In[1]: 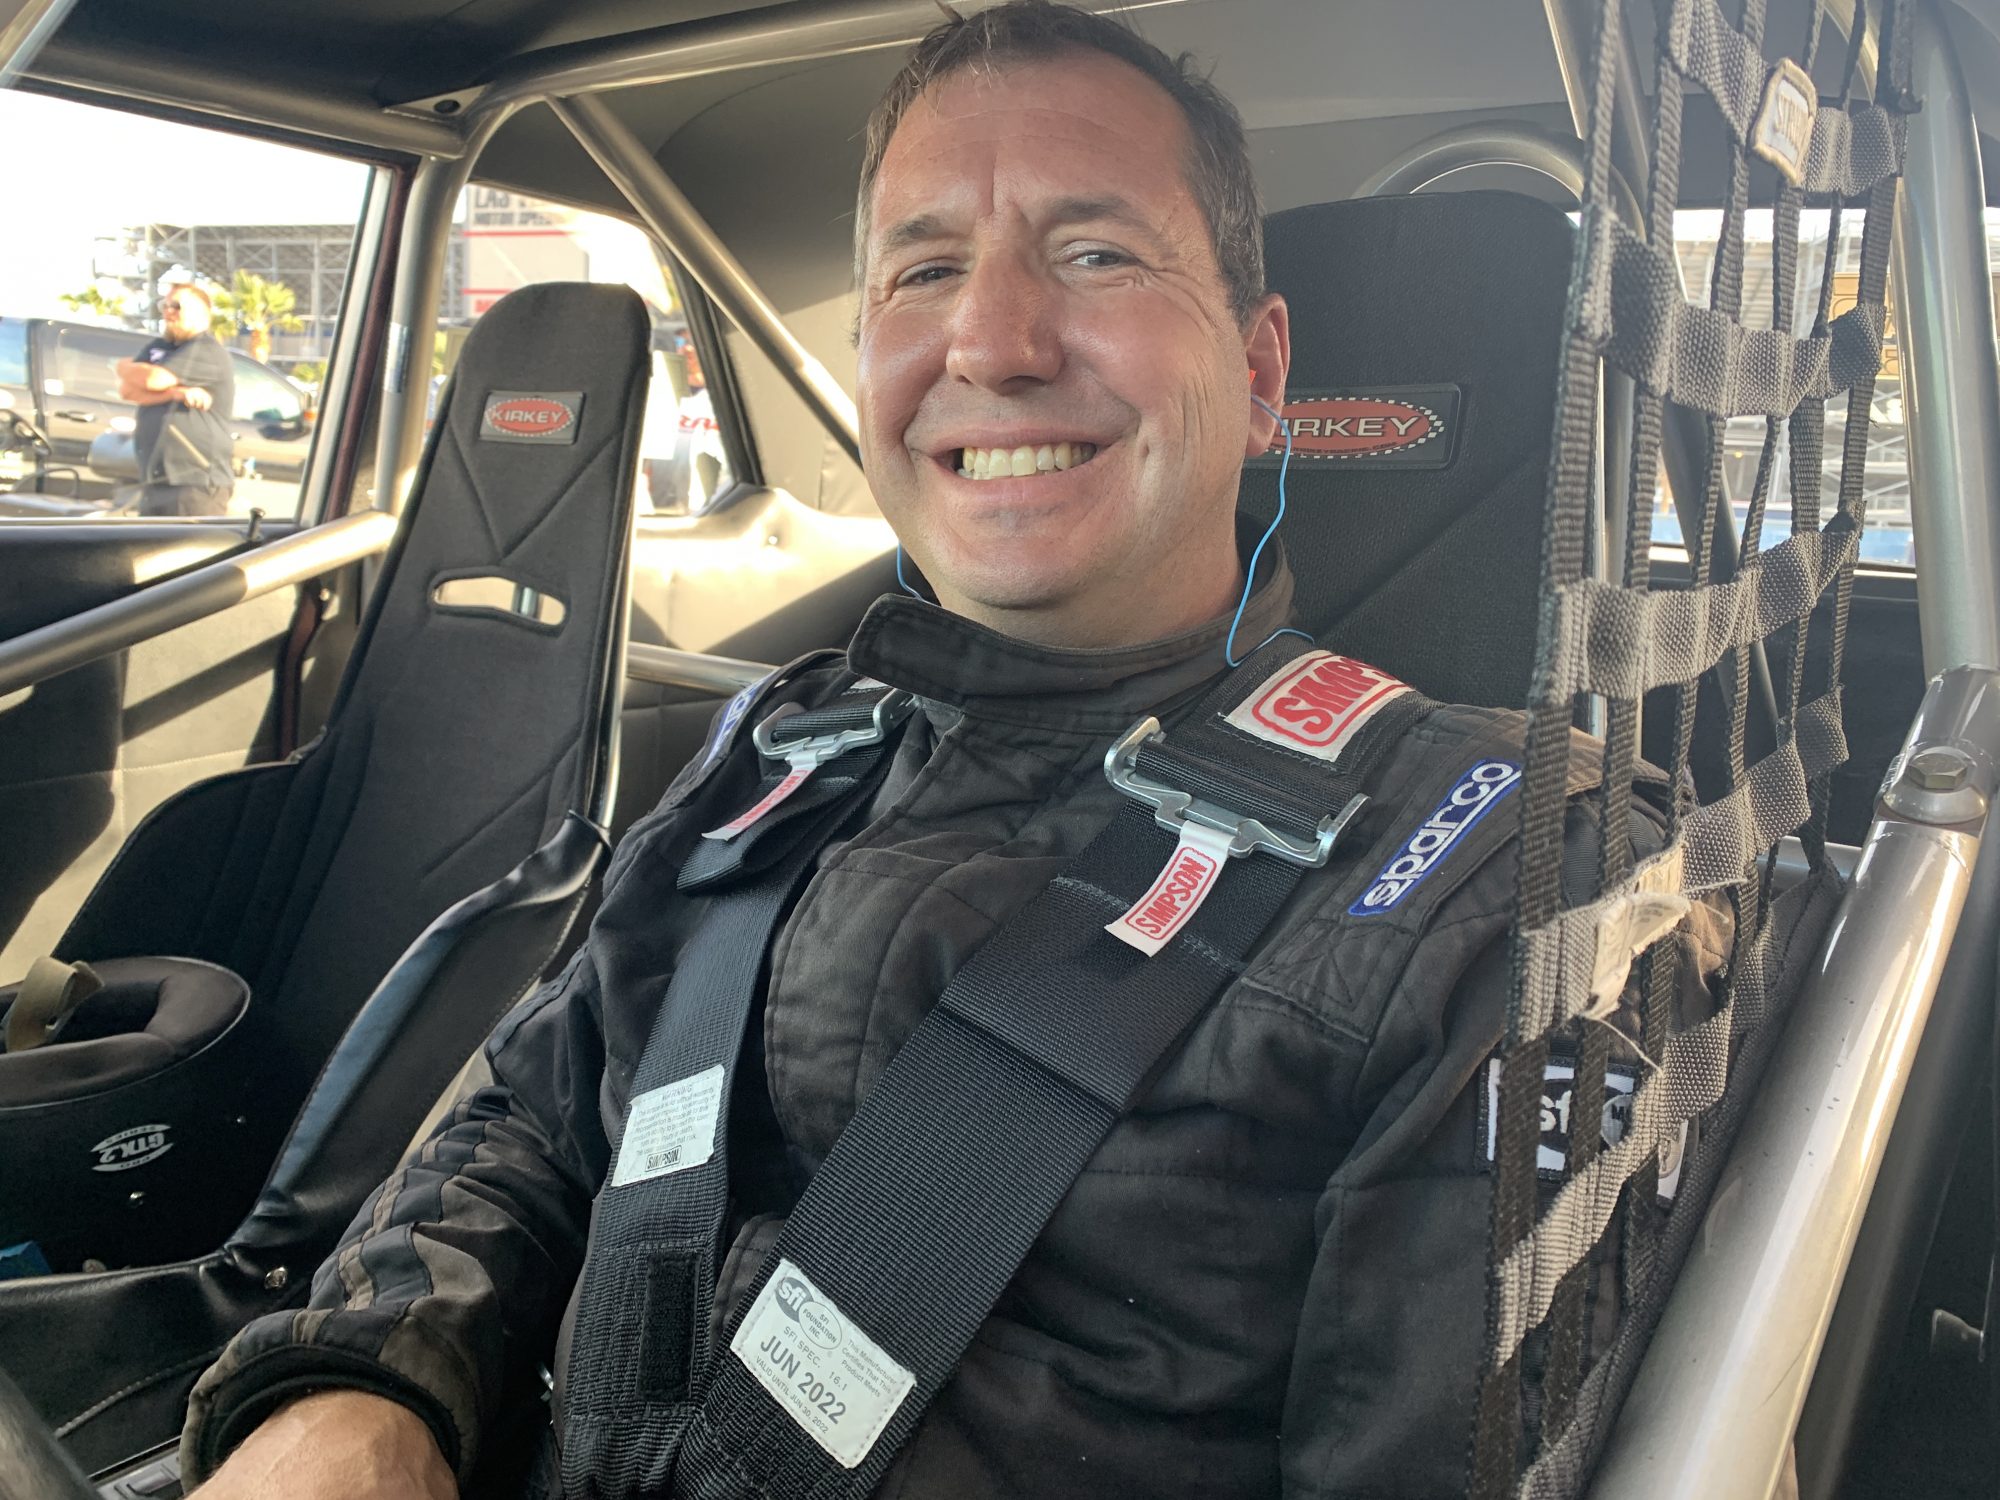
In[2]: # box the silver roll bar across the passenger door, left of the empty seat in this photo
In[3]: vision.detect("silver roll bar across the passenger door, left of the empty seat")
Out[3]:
[0,510,396,694]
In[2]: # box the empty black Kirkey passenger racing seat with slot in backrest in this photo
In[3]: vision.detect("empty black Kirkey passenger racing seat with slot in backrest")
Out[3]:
[0,284,650,1464]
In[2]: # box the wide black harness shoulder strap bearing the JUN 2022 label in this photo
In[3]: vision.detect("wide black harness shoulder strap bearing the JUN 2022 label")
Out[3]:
[664,640,1430,1500]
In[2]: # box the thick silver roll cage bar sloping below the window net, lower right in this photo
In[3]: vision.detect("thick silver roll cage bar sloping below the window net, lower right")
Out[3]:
[1590,668,2000,1500]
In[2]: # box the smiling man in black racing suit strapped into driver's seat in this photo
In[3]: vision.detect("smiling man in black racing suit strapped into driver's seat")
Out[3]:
[182,0,1714,1500]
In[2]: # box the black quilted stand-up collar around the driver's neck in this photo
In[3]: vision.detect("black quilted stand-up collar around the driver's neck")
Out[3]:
[848,522,1292,736]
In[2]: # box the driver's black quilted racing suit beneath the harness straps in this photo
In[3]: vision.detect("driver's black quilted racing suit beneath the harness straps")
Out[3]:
[184,564,1724,1500]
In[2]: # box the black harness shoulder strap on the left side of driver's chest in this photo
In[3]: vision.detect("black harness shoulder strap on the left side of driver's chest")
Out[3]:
[562,684,914,1494]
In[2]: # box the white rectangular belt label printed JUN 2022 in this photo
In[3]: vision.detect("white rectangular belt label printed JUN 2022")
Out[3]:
[730,1260,916,1468]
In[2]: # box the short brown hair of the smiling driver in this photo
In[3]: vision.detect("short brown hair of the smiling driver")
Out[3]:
[854,0,1264,322]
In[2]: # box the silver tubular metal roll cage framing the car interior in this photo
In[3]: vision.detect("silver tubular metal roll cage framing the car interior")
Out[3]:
[0,0,2000,1500]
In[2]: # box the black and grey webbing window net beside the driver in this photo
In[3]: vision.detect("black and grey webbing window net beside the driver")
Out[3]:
[1472,0,1908,1500]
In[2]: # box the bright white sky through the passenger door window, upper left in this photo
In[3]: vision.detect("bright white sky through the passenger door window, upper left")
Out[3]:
[0,92,368,318]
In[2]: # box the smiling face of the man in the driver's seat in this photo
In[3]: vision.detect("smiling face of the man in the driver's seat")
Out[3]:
[858,52,1290,646]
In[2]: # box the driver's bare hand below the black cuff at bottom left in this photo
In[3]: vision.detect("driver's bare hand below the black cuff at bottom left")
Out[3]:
[196,1390,458,1500]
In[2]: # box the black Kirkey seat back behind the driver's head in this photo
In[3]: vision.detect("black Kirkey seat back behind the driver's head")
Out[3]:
[1242,192,1576,708]
